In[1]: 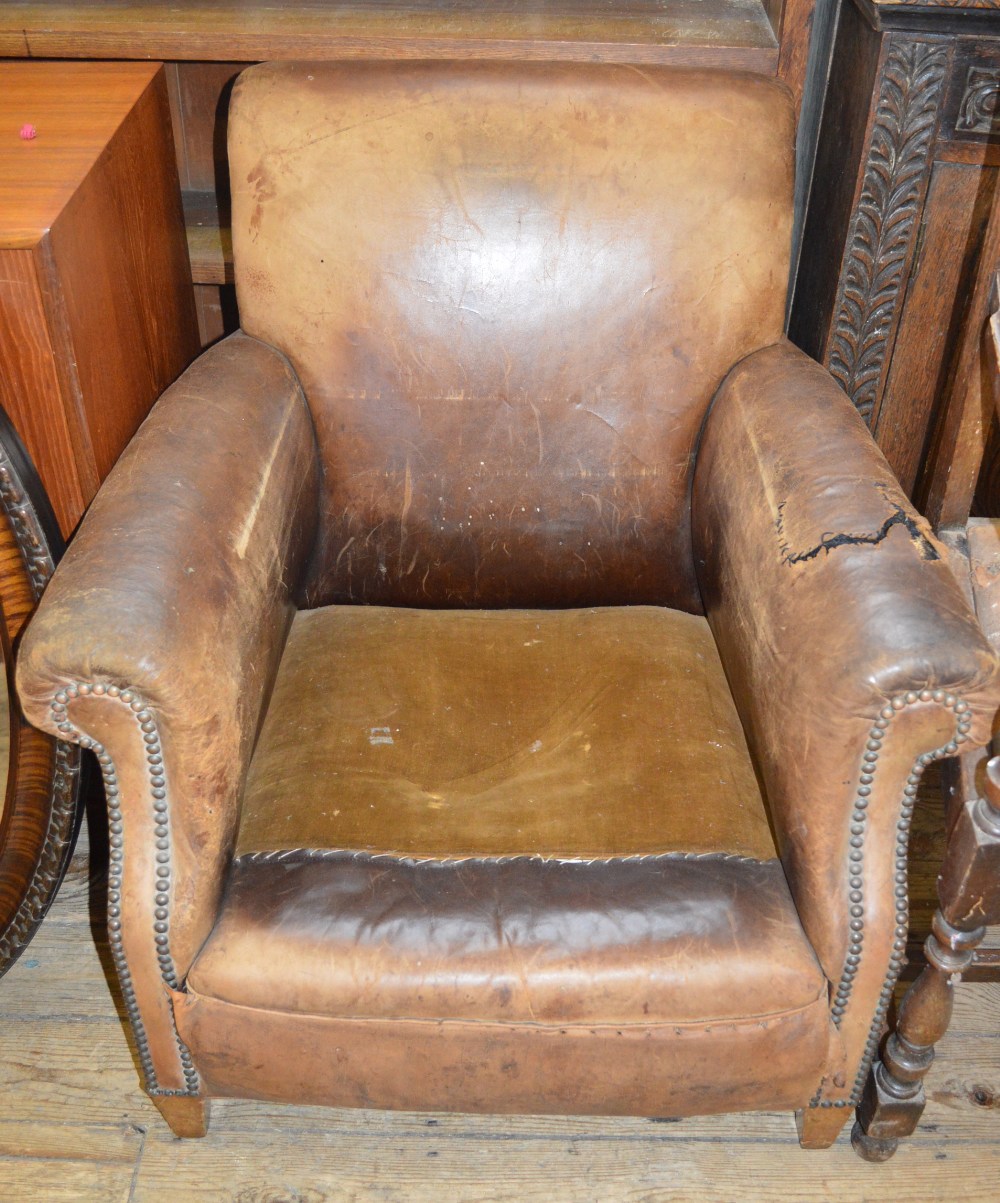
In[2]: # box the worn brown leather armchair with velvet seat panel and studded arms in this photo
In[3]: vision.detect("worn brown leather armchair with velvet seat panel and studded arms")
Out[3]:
[19,63,1000,1146]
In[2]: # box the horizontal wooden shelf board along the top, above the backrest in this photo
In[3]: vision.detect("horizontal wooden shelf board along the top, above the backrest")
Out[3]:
[0,0,777,75]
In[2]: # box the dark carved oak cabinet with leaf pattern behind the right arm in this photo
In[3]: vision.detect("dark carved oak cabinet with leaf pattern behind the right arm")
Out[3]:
[789,0,1000,502]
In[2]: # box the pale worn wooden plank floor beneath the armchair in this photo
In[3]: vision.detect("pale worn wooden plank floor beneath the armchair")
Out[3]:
[0,789,1000,1203]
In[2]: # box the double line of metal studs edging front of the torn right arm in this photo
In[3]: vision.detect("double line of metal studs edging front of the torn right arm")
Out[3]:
[811,689,972,1107]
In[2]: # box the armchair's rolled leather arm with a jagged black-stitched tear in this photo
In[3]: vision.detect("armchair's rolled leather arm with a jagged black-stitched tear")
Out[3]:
[692,342,1000,1094]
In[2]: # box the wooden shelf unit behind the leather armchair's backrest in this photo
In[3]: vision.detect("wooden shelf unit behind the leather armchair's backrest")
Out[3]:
[0,0,816,343]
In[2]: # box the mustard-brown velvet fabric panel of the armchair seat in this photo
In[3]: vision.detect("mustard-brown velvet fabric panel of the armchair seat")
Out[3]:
[237,606,776,859]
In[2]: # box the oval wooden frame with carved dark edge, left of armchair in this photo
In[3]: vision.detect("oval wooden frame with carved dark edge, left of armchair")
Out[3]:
[0,409,81,976]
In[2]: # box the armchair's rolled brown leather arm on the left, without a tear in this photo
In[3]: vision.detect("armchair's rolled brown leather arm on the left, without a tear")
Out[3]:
[17,334,318,983]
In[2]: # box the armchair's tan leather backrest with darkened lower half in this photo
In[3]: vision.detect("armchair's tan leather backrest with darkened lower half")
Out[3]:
[230,63,793,610]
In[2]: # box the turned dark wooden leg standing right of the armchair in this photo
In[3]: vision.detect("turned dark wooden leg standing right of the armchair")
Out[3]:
[851,757,1000,1161]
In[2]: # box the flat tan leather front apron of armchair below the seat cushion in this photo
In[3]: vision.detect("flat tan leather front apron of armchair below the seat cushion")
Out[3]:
[174,994,827,1116]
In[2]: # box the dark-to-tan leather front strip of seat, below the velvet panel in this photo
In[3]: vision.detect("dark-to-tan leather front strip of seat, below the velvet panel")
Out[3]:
[188,854,827,1026]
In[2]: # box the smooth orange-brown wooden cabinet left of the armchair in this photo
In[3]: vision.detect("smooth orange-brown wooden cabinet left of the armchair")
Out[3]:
[0,63,199,535]
